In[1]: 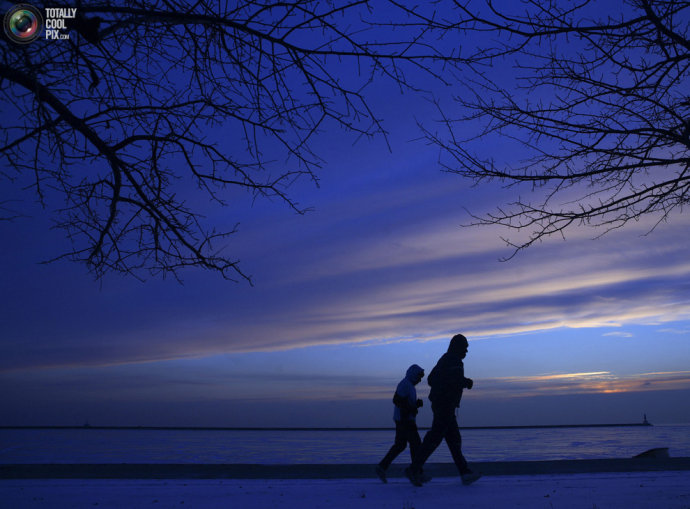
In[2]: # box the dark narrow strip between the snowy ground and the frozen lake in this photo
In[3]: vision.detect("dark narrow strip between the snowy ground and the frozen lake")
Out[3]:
[0,458,690,479]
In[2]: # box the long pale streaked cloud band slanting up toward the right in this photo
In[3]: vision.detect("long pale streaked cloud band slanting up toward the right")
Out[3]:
[2,211,690,370]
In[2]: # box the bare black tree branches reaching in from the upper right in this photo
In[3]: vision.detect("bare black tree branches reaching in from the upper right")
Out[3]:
[411,0,690,255]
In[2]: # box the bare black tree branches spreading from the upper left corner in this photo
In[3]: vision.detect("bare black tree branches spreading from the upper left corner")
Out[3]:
[0,0,462,279]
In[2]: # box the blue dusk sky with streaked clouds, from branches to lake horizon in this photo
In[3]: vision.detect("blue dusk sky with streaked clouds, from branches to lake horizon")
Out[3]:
[0,0,690,426]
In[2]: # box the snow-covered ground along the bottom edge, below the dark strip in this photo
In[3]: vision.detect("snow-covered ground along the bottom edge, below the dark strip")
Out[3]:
[0,471,690,509]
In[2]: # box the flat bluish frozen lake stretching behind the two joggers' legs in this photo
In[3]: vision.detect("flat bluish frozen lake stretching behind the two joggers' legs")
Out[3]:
[0,425,690,464]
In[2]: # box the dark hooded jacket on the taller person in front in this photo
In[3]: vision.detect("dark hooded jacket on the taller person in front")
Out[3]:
[427,335,471,408]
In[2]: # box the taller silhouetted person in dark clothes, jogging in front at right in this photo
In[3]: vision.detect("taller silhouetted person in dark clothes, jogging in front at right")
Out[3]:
[405,334,481,486]
